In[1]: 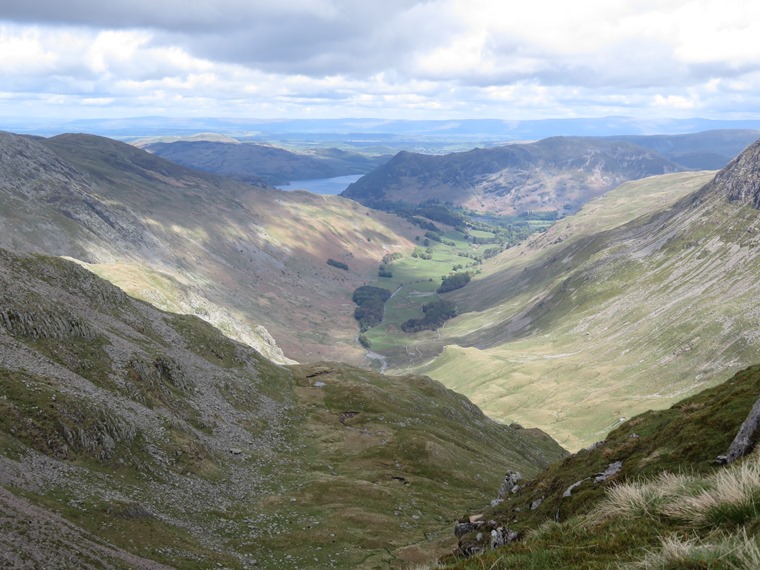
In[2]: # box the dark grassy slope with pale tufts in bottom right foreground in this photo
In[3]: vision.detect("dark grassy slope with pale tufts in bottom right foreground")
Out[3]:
[446,366,760,570]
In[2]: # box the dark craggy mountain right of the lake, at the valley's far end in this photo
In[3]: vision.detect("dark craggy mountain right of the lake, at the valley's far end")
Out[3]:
[342,137,684,215]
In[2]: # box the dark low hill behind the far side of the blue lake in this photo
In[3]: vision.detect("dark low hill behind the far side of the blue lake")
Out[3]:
[139,141,388,184]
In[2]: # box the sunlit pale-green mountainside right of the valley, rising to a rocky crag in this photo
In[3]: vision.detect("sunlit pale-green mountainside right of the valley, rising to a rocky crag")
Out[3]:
[407,138,760,449]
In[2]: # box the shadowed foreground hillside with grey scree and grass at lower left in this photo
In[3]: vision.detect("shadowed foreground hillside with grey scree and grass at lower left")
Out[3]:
[0,250,564,568]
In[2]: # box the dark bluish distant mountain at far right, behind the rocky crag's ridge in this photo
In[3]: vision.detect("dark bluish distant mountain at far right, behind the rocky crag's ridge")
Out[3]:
[609,129,760,170]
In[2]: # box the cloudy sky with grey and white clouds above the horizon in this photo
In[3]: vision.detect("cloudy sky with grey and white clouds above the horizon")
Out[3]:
[0,0,760,120]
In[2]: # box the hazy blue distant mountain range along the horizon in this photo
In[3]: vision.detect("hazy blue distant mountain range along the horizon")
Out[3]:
[5,113,760,140]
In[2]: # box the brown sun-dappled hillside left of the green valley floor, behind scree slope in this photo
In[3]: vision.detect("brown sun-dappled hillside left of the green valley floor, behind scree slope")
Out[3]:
[0,133,414,363]
